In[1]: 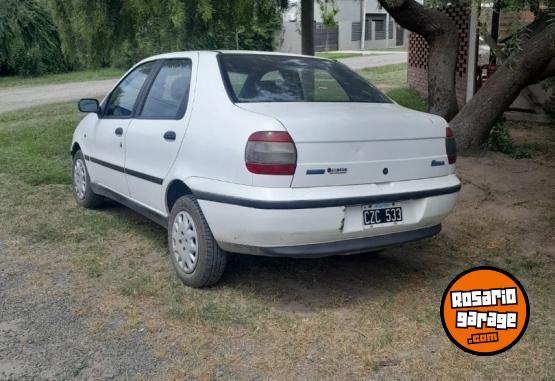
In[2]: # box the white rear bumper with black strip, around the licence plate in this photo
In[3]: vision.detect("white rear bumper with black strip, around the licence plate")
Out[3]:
[188,175,460,257]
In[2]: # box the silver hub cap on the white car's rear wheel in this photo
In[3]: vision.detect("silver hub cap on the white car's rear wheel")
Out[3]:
[172,212,202,273]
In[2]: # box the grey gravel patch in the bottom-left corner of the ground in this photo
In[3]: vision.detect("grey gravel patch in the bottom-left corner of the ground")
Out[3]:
[0,259,158,381]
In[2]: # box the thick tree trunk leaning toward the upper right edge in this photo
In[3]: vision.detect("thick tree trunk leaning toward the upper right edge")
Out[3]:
[450,22,555,151]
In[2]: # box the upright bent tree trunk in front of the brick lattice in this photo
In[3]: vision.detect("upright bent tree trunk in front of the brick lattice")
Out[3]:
[378,0,459,120]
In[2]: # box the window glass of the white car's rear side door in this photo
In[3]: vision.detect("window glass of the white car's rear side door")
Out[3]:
[141,59,191,119]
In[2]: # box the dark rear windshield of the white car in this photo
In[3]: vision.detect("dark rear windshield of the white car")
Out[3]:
[219,54,391,103]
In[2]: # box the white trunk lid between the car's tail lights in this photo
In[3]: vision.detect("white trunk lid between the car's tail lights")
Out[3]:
[238,102,450,187]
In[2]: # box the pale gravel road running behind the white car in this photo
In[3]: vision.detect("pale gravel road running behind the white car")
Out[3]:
[0,52,407,113]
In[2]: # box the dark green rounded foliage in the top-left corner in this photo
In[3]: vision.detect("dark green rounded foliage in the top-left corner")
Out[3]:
[0,0,65,75]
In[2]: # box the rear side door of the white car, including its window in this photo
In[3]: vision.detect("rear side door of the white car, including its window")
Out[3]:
[125,53,198,213]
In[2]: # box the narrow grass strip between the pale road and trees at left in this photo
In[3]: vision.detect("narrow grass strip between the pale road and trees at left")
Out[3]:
[0,69,124,89]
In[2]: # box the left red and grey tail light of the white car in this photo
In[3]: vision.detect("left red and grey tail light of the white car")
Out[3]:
[245,131,297,175]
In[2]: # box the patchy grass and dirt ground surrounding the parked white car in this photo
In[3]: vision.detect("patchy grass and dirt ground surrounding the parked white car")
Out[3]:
[0,100,555,380]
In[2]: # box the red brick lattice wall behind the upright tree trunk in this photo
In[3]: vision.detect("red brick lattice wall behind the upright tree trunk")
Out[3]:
[407,5,470,107]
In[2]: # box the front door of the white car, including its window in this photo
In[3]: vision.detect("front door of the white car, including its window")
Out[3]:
[85,61,156,196]
